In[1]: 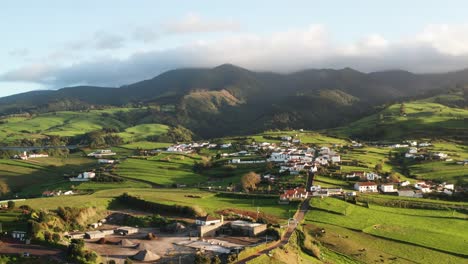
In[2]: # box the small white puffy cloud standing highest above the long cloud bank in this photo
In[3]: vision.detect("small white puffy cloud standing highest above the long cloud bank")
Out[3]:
[164,14,241,34]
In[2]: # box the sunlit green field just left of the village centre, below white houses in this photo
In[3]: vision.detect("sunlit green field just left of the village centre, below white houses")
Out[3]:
[117,153,207,185]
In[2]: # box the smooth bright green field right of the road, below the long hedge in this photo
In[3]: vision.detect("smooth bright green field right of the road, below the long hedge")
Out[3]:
[306,198,468,256]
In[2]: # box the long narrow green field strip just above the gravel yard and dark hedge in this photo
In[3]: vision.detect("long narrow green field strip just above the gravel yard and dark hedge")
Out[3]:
[17,188,296,222]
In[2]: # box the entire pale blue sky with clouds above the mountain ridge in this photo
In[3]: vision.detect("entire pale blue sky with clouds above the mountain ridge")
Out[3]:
[0,0,468,96]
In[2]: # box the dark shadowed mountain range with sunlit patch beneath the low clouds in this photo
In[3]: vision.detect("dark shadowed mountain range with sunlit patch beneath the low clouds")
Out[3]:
[0,64,468,138]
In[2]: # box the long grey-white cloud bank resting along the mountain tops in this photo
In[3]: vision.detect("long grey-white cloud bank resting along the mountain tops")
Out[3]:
[0,21,468,88]
